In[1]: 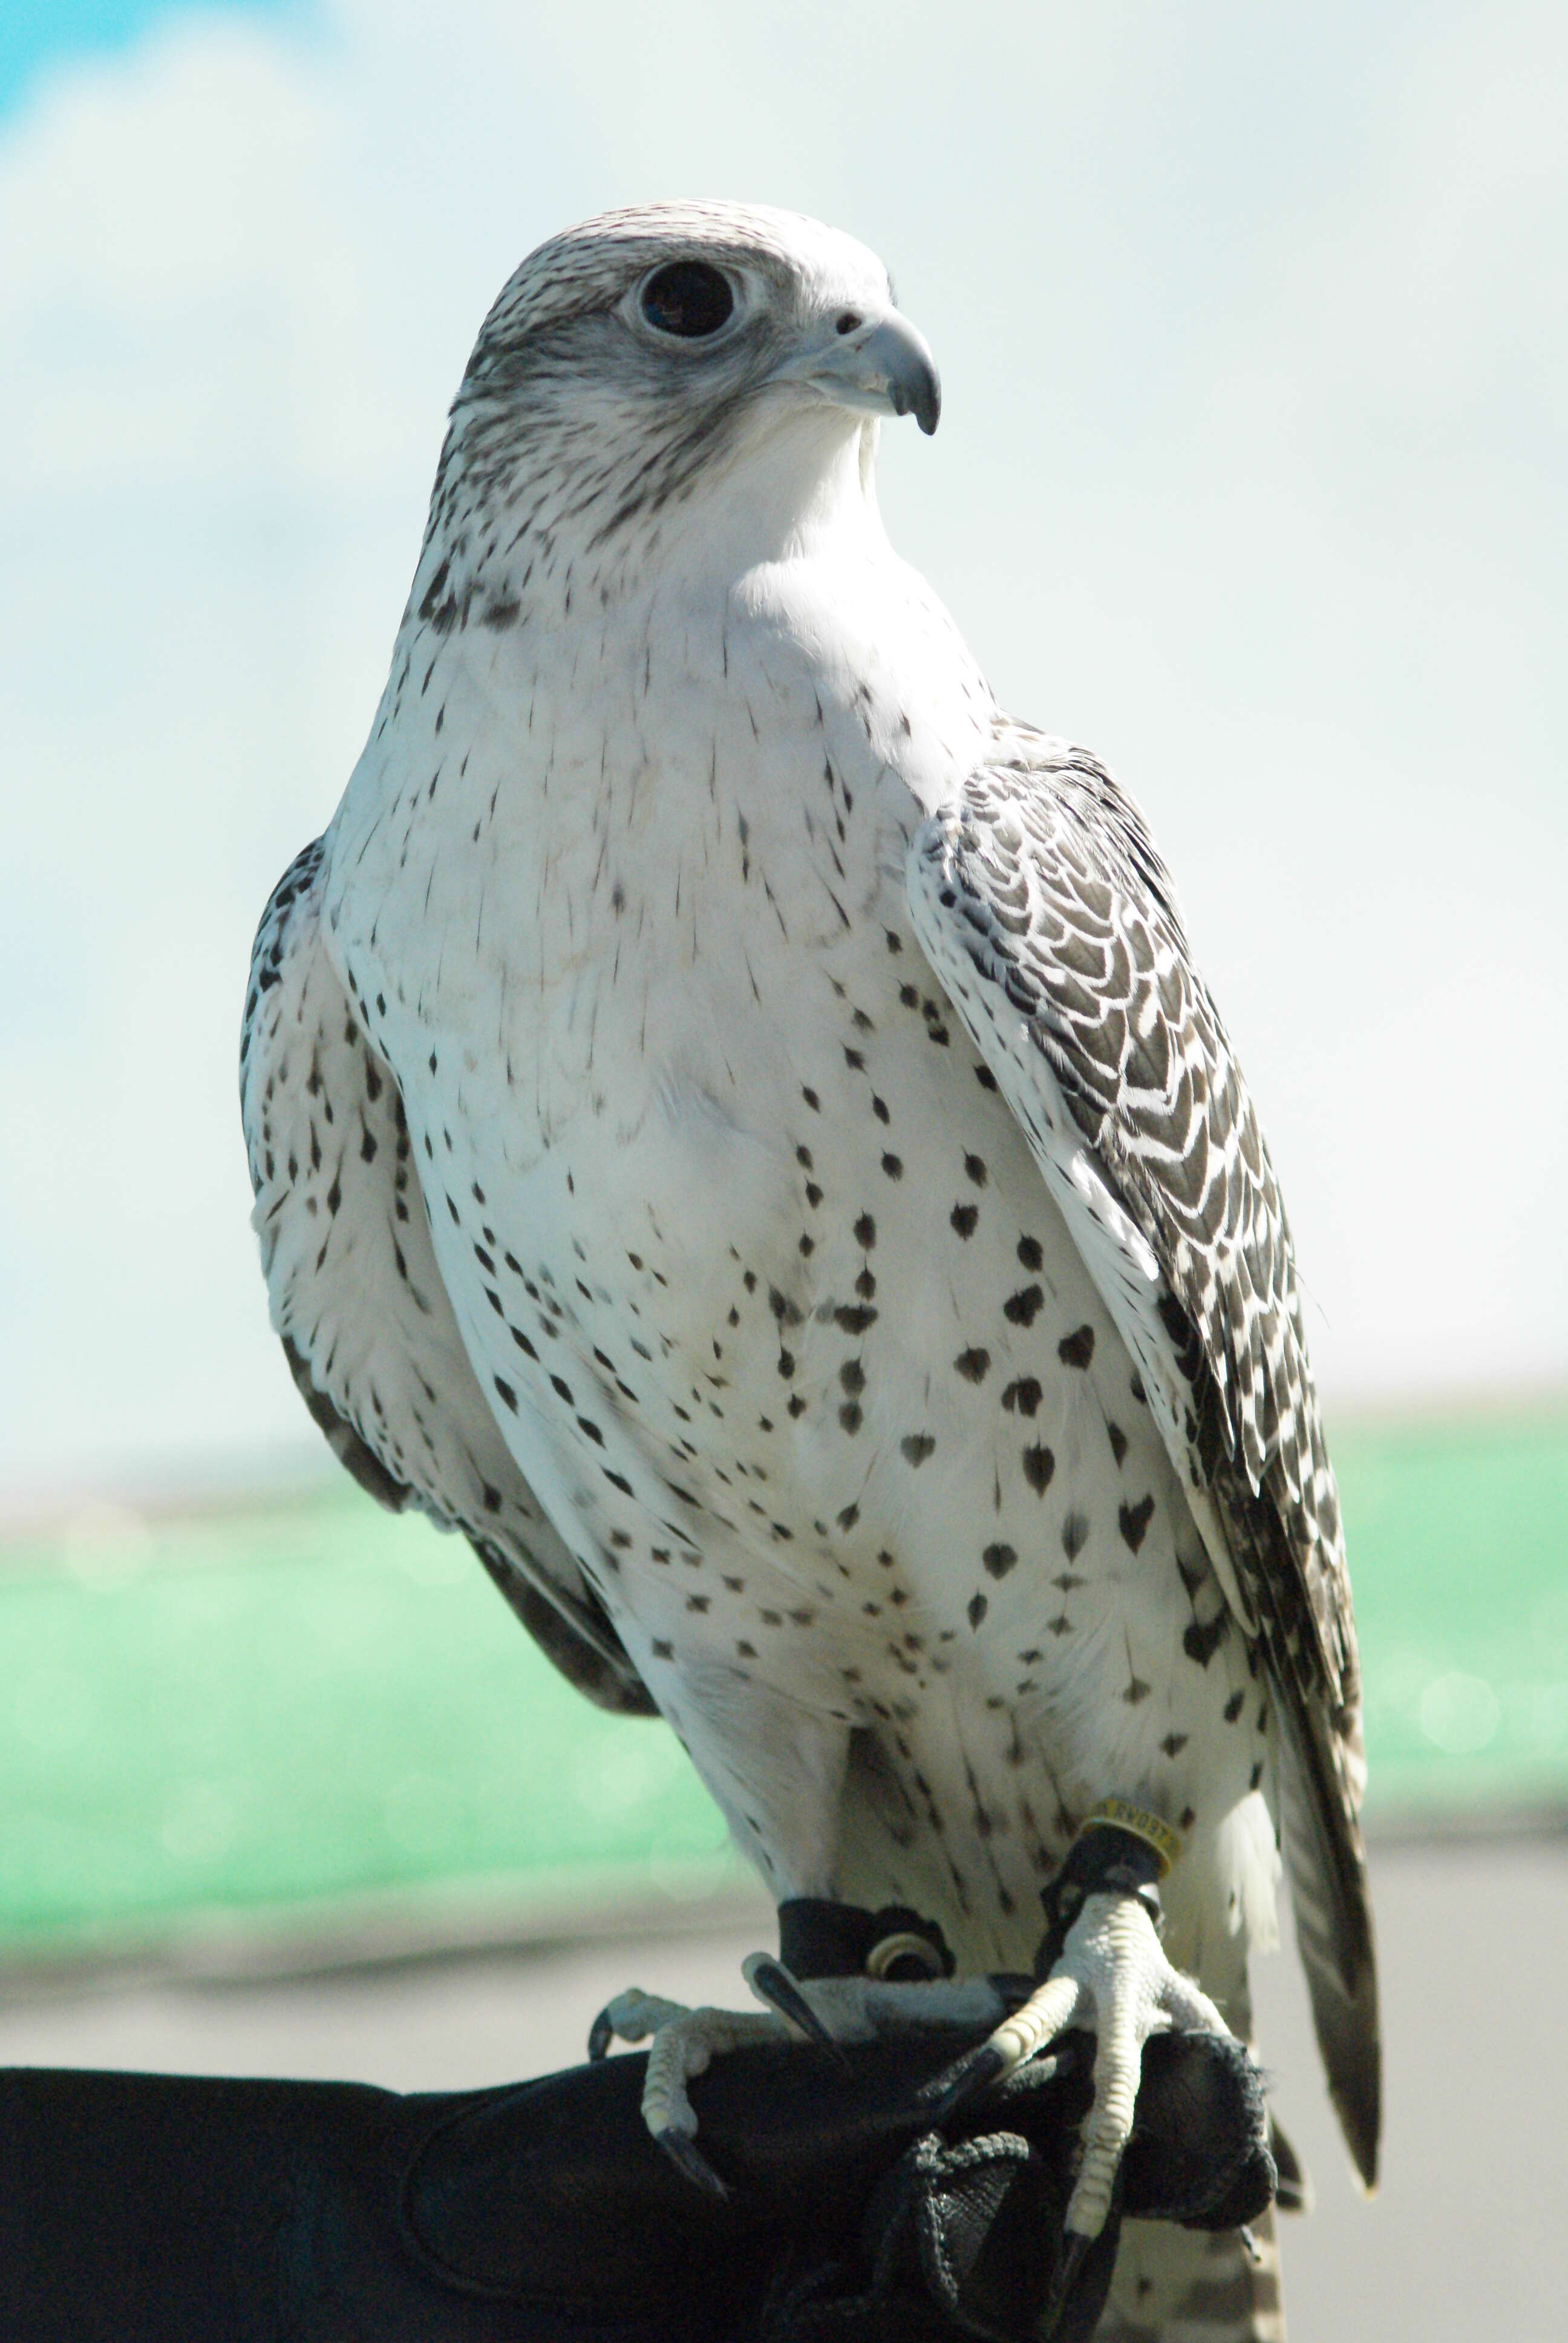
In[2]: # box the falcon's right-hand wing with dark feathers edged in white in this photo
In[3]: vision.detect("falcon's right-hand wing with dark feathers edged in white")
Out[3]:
[907,726,1380,2184]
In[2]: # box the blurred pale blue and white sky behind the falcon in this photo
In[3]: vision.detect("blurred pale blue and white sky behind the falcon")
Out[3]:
[0,0,1568,1502]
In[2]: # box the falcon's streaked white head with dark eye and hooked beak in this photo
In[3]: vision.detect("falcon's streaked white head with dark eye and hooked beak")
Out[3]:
[431,204,942,595]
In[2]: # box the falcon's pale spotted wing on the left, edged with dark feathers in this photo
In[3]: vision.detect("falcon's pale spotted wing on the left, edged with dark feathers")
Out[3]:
[239,841,656,1715]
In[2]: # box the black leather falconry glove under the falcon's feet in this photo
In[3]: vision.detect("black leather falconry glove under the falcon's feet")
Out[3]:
[0,2029,1273,2343]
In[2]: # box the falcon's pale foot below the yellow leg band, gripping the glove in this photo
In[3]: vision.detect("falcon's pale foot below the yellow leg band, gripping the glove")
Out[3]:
[935,1804,1230,2243]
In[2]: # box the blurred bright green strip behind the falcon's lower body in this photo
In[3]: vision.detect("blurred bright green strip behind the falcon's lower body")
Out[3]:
[0,1411,1568,1959]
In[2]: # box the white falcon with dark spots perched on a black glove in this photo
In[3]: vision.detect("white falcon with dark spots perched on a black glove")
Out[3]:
[241,204,1378,2336]
